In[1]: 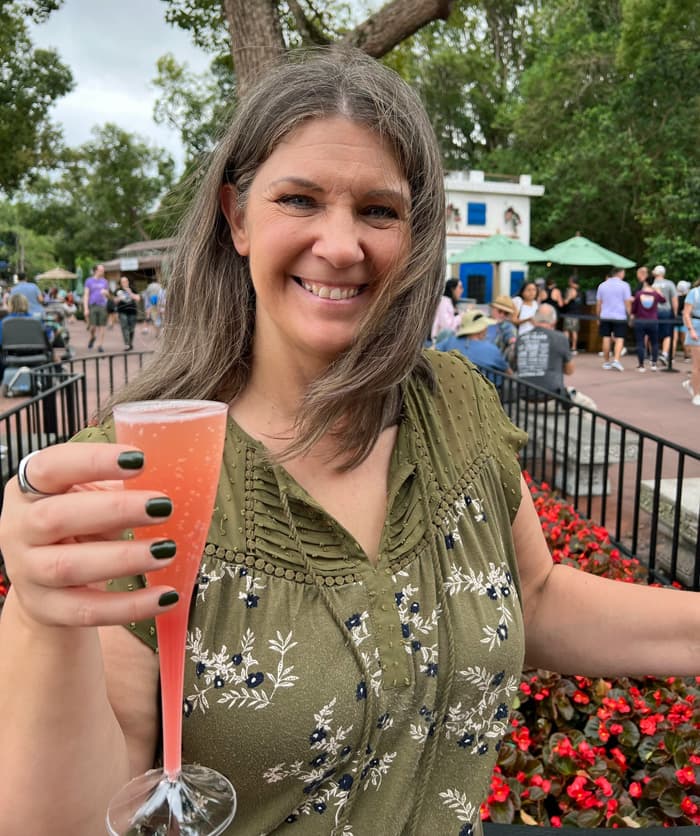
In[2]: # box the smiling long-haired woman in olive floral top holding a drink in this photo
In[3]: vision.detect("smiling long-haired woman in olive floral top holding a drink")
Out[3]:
[0,50,700,836]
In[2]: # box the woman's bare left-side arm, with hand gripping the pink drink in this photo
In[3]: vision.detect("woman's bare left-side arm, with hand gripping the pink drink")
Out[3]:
[0,444,174,836]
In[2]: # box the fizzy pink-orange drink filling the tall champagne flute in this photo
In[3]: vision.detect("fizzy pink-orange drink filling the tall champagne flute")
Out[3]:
[114,401,227,779]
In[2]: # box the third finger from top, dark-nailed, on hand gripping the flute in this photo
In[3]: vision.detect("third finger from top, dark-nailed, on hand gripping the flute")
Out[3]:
[31,539,177,589]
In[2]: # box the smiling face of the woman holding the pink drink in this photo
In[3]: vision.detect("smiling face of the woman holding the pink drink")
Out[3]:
[221,117,411,364]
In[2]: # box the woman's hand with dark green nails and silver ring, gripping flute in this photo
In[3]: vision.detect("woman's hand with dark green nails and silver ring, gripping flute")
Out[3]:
[0,443,177,627]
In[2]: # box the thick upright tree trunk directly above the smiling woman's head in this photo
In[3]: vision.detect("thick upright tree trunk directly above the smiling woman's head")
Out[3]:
[223,0,285,96]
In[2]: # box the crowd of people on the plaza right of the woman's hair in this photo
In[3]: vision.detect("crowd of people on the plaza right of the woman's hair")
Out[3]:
[430,264,700,406]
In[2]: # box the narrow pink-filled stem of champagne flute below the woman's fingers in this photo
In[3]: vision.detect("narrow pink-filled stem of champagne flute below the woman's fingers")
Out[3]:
[156,596,188,780]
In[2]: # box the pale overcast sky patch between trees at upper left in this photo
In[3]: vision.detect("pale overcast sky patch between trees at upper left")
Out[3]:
[31,0,209,170]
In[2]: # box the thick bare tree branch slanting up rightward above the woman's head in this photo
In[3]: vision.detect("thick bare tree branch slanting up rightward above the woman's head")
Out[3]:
[340,0,454,58]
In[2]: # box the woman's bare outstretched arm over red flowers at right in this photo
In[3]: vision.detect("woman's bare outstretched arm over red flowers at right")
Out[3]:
[513,480,700,676]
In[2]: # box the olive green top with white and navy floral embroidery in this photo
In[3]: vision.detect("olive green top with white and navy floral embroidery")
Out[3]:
[77,351,525,836]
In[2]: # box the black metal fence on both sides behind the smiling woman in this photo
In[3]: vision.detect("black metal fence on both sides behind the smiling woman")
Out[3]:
[0,352,700,589]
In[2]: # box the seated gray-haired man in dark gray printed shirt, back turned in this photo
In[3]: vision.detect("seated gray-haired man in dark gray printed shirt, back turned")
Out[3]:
[516,303,574,400]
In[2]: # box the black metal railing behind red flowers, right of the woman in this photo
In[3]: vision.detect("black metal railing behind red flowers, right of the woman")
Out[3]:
[488,370,700,590]
